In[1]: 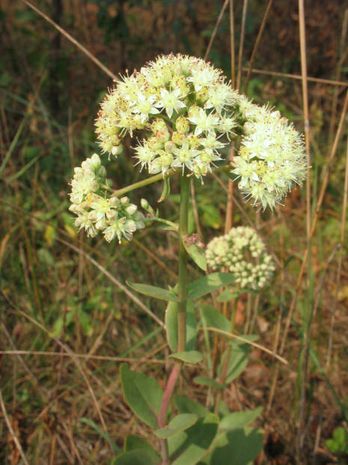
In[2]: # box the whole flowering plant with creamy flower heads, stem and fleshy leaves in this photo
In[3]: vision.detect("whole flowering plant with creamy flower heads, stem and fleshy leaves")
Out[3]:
[70,55,306,465]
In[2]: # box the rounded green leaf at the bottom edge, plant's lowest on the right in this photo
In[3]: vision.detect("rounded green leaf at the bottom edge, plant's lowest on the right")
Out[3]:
[210,429,262,465]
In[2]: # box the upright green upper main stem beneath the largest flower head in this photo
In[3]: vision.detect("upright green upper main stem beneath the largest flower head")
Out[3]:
[177,176,190,352]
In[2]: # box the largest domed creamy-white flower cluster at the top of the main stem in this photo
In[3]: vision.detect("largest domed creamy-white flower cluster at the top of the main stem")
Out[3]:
[96,55,239,177]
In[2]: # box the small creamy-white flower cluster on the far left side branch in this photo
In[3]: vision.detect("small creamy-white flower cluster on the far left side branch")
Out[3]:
[69,154,144,242]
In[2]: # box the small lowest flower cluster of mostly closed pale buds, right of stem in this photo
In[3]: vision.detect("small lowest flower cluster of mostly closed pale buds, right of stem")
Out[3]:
[206,226,275,291]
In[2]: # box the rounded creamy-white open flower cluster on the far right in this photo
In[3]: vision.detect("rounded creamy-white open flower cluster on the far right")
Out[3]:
[232,96,307,209]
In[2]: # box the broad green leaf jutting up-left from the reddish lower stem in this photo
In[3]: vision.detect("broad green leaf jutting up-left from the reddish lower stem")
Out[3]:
[120,365,163,429]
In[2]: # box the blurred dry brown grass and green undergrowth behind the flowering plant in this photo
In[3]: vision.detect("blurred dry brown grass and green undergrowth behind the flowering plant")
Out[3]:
[0,0,348,465]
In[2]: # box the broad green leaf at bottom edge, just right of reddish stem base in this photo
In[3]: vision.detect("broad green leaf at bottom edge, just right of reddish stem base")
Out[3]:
[168,414,219,465]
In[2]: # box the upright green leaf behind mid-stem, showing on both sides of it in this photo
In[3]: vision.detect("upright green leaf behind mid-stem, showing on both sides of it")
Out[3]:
[165,300,197,352]
